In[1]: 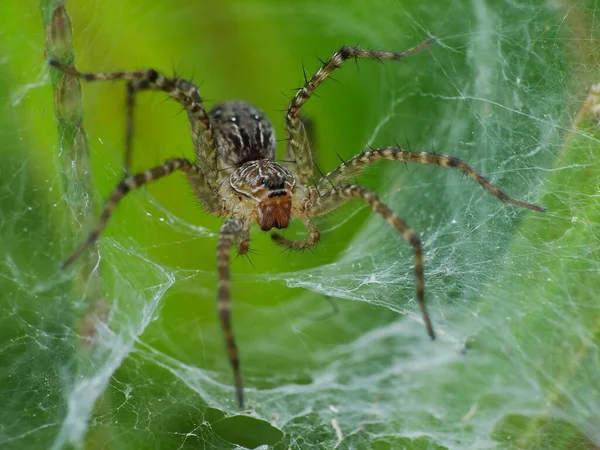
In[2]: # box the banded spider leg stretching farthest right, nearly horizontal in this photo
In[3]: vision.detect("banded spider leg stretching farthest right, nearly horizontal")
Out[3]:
[317,147,545,212]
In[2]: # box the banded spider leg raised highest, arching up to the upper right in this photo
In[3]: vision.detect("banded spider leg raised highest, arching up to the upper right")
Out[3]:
[285,38,435,183]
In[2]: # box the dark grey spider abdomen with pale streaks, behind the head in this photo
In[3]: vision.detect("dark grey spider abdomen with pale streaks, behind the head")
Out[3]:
[208,100,275,169]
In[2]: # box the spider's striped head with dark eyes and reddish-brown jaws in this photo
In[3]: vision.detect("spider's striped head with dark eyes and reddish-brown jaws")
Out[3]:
[230,159,296,231]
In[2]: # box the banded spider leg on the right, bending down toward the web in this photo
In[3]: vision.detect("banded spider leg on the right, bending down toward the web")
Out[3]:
[308,184,435,339]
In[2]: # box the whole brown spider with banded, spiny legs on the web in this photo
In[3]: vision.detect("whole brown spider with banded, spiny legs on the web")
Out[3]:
[49,38,544,408]
